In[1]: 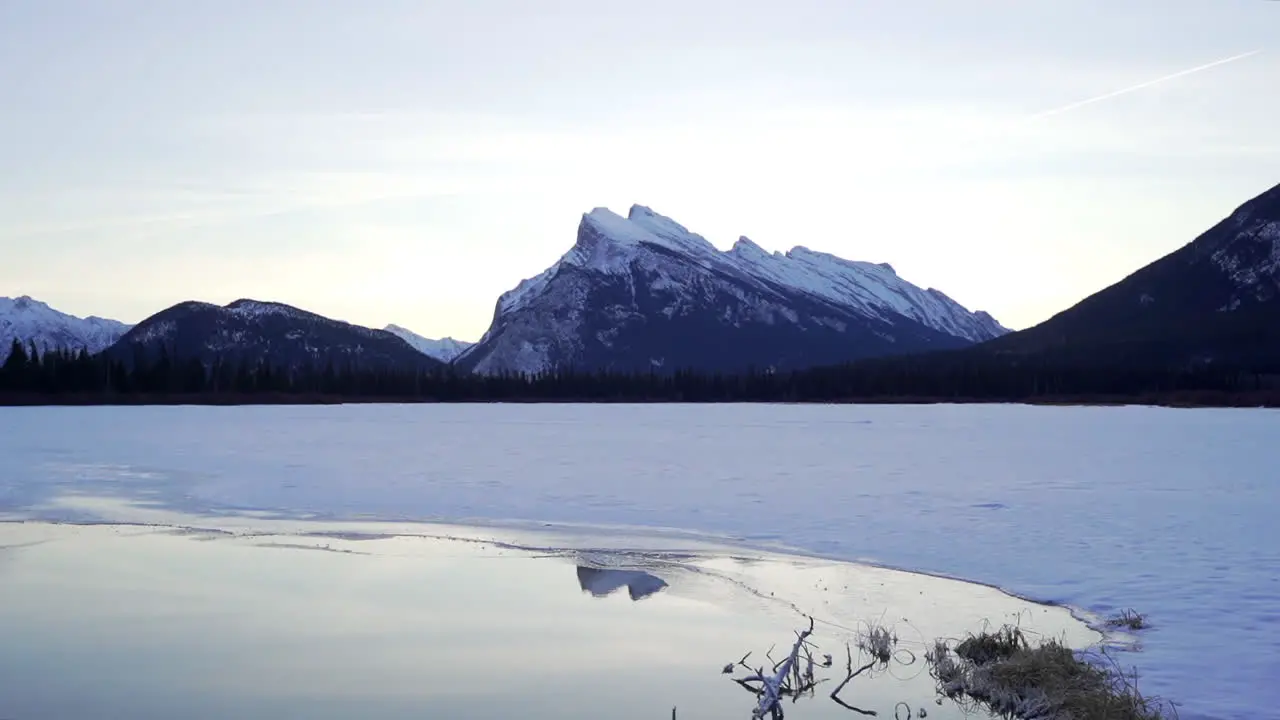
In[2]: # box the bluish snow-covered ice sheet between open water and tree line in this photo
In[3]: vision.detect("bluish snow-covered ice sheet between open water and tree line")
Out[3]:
[0,405,1280,720]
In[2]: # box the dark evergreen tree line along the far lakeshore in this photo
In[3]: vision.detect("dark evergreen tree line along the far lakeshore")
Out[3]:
[0,341,1280,405]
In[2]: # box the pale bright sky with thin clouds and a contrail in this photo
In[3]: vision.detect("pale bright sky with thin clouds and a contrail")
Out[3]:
[0,0,1280,340]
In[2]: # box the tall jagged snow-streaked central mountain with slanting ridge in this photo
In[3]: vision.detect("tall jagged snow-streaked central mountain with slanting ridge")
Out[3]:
[456,205,1009,373]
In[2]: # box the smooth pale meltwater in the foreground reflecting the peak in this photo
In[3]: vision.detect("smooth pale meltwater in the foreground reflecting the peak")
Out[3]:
[0,523,1098,720]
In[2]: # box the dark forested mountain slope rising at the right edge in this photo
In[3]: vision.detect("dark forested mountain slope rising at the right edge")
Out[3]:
[979,179,1280,365]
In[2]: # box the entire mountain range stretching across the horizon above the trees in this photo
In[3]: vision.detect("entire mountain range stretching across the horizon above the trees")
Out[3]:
[0,186,1280,374]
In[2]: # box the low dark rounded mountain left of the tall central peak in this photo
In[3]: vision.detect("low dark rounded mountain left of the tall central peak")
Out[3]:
[108,300,440,369]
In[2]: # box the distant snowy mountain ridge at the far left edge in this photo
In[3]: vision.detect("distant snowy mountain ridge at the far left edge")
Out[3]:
[0,295,129,361]
